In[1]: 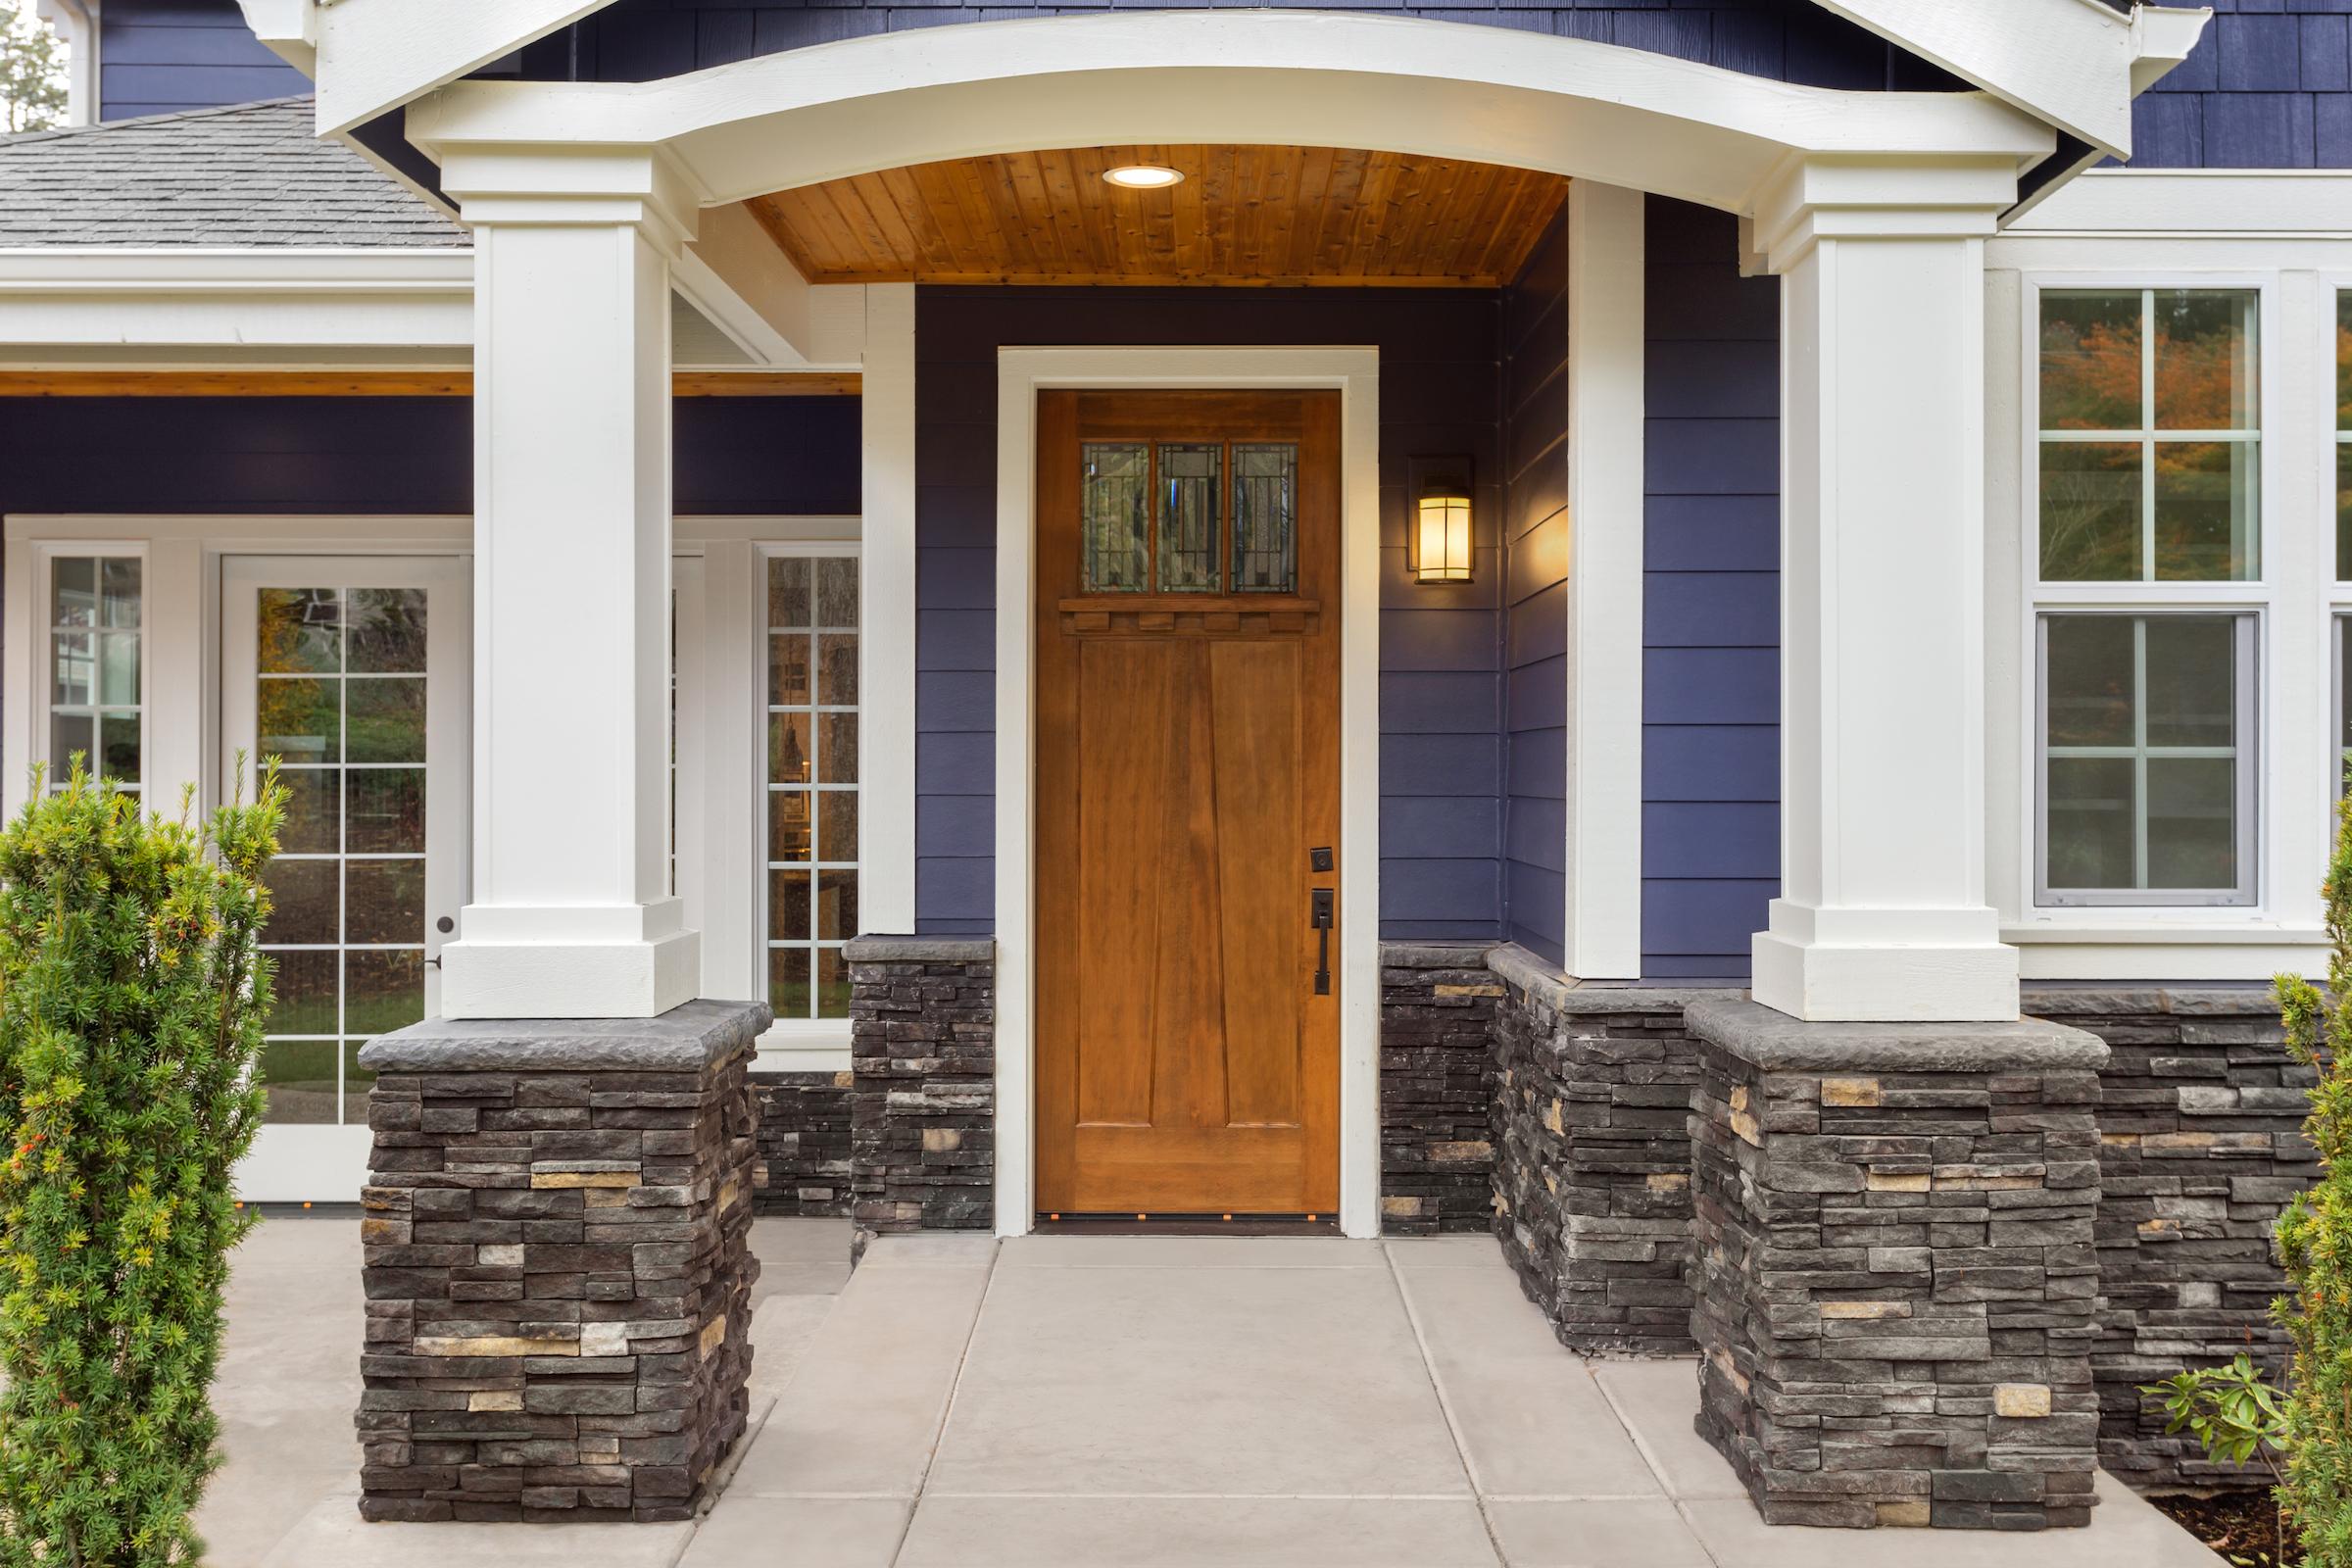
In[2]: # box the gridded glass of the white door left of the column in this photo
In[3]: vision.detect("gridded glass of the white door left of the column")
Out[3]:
[254,585,425,1126]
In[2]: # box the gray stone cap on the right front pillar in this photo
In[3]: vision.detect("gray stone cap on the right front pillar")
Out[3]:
[1684,997,2107,1072]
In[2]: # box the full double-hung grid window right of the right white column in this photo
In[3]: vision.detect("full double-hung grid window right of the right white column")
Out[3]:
[2034,289,2263,906]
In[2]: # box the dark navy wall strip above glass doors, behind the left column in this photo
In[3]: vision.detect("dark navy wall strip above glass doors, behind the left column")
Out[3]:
[0,397,858,514]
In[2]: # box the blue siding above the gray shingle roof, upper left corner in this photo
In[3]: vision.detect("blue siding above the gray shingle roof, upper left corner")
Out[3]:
[99,0,311,120]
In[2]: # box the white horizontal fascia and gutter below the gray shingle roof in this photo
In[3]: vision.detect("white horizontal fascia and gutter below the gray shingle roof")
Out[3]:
[0,247,472,350]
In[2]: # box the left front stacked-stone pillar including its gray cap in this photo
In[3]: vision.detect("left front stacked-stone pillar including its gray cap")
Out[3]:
[358,1002,769,1521]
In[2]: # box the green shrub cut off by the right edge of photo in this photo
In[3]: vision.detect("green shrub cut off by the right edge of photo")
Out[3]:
[2272,790,2352,1568]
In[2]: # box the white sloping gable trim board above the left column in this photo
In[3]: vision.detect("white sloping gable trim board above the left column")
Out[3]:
[313,0,612,131]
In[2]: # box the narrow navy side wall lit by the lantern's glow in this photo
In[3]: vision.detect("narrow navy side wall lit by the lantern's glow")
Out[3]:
[1503,209,1569,964]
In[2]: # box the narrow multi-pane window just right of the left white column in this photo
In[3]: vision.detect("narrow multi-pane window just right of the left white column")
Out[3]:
[766,546,858,1022]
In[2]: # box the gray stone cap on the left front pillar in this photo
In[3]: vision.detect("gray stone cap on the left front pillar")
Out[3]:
[360,1002,774,1072]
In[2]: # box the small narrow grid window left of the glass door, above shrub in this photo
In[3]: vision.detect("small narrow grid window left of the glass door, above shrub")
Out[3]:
[47,555,143,795]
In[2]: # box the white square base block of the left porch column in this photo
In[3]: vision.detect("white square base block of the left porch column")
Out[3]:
[440,931,704,1018]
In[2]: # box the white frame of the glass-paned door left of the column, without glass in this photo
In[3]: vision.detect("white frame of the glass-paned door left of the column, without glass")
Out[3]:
[214,553,472,1203]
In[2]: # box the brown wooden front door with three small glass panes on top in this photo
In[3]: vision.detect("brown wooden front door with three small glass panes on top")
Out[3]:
[1037,393,1341,1215]
